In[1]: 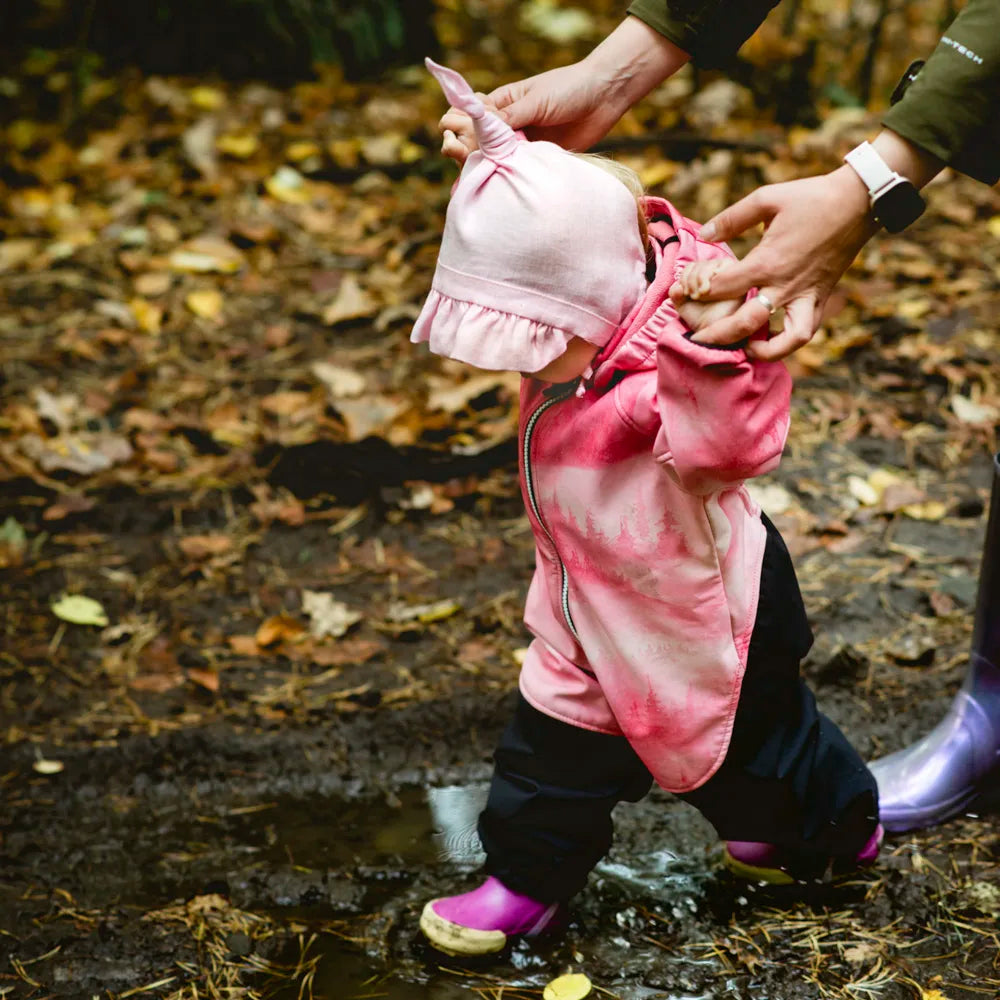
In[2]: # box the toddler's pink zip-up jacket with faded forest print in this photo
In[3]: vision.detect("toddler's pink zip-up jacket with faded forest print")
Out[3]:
[520,198,791,792]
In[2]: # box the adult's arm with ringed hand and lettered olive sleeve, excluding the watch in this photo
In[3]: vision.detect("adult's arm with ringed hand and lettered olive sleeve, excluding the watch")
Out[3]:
[672,0,1000,359]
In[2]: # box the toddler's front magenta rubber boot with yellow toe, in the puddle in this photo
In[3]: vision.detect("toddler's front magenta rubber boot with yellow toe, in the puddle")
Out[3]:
[420,876,562,955]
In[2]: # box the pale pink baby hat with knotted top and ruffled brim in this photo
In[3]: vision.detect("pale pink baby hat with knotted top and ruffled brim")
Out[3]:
[410,59,646,373]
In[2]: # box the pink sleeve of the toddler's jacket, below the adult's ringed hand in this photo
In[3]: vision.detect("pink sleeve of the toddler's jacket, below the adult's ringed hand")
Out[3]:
[653,332,791,494]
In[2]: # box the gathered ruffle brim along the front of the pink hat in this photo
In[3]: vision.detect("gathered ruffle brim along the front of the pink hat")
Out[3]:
[410,289,573,372]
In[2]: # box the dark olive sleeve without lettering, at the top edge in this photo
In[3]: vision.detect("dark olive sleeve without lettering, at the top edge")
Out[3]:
[628,0,778,69]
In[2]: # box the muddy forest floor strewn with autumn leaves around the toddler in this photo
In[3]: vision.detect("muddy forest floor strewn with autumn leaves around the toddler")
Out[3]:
[0,3,1000,1000]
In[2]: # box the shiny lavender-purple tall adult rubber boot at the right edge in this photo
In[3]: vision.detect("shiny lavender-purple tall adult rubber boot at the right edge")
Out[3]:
[870,456,1000,832]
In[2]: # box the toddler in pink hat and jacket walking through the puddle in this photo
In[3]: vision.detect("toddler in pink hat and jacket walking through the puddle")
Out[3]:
[412,60,881,955]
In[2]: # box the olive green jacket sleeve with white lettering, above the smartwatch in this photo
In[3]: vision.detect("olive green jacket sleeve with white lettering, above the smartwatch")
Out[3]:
[882,0,1000,184]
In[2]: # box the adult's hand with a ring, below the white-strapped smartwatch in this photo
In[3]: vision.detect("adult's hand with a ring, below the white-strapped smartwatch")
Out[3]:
[670,166,878,361]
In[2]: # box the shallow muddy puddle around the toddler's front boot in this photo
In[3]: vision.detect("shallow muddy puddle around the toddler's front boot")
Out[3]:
[262,781,747,1000]
